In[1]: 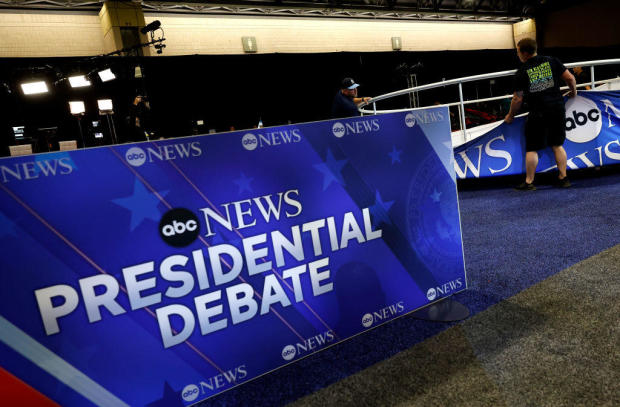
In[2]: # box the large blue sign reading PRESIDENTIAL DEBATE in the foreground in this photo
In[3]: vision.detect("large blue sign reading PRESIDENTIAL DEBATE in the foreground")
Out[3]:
[0,108,466,406]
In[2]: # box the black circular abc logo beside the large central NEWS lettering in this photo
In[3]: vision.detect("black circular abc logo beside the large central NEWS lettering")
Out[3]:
[159,208,200,247]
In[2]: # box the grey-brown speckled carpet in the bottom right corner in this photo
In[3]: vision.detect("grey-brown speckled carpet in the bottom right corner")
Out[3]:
[291,245,620,407]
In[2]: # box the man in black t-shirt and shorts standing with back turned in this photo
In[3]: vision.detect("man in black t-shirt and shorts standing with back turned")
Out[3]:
[504,38,577,191]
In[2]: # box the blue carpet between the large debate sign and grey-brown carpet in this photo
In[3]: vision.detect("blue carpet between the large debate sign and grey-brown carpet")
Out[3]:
[200,173,620,406]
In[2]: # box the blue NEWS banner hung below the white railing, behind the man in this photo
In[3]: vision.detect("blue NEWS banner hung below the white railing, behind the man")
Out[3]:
[454,91,620,179]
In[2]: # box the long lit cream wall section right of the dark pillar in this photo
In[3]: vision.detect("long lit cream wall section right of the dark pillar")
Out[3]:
[145,13,514,55]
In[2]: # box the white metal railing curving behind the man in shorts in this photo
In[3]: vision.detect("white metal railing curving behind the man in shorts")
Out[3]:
[359,59,620,143]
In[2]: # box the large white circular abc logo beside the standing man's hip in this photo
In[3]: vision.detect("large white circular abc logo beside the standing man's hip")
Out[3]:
[566,96,603,143]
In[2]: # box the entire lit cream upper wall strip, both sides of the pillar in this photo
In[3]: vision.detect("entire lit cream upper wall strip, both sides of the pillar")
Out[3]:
[0,10,514,57]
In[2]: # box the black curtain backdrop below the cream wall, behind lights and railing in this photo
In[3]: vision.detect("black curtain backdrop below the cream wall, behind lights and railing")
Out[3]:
[0,47,620,155]
